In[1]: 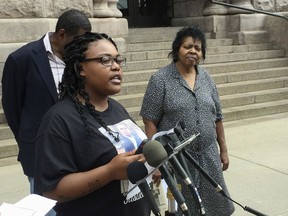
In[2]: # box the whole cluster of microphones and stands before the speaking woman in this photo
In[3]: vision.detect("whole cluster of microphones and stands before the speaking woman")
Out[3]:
[127,124,266,216]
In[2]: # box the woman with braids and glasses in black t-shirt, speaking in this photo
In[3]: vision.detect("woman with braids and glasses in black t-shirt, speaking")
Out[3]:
[35,33,150,216]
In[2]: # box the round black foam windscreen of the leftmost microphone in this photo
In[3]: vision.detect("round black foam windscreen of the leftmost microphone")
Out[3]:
[127,161,148,184]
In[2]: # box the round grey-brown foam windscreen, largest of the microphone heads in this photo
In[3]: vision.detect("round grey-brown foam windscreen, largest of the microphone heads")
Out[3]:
[143,140,168,167]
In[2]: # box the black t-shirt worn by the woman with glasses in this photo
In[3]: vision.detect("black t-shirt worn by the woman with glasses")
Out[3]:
[35,98,150,216]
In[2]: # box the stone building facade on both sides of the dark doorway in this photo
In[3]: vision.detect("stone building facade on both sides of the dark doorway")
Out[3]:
[0,0,288,66]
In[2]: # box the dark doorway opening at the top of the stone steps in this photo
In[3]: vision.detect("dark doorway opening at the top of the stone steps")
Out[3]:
[117,0,170,28]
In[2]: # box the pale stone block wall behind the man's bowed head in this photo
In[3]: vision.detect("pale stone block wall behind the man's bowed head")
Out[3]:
[0,0,128,74]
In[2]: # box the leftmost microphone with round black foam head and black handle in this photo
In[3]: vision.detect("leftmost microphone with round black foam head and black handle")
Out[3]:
[127,161,161,216]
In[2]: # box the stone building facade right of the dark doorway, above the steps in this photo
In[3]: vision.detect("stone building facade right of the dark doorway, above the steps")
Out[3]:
[171,0,288,55]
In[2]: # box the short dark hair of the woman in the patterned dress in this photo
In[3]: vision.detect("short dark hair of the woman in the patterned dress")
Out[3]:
[168,26,206,62]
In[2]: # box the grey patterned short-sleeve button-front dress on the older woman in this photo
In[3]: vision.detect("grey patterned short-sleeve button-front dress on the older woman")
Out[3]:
[140,62,234,216]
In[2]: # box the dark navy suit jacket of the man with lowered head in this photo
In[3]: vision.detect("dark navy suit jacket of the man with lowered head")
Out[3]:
[2,37,57,177]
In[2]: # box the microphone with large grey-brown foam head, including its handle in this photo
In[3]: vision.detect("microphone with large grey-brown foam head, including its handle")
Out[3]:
[143,140,190,216]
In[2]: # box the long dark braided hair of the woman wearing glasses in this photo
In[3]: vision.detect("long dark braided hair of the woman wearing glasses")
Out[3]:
[59,32,119,142]
